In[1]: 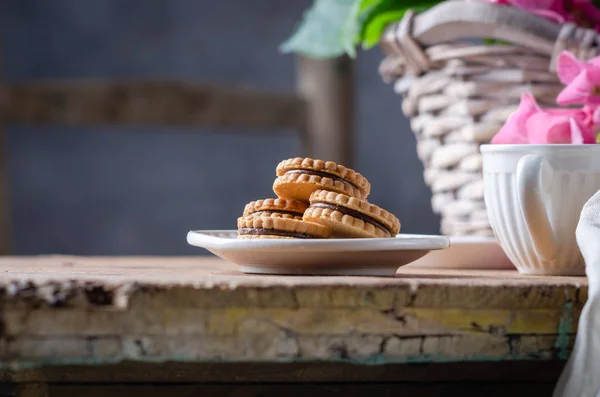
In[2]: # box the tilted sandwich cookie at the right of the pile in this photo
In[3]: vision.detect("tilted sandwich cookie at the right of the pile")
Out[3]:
[303,190,400,238]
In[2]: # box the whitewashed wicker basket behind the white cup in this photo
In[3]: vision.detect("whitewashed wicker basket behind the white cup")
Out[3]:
[380,1,600,236]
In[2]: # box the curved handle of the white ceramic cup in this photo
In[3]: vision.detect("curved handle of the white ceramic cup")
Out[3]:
[517,154,556,261]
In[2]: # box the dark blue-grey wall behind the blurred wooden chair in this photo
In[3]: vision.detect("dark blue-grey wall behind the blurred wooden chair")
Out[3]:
[0,0,439,255]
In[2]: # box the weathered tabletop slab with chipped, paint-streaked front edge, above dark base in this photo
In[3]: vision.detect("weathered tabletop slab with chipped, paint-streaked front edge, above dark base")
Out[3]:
[0,256,587,369]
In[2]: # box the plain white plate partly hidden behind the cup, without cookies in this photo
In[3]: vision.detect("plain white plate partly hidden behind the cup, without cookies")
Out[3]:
[409,236,515,269]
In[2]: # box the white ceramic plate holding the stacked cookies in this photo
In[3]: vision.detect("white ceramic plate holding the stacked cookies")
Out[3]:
[187,230,450,276]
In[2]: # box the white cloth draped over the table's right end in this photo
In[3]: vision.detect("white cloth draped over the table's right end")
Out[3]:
[553,191,600,397]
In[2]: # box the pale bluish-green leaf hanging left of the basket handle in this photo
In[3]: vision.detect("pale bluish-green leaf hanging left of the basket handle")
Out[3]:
[279,0,360,58]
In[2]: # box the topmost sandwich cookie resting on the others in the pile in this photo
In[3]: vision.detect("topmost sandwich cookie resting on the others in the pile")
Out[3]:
[273,158,371,201]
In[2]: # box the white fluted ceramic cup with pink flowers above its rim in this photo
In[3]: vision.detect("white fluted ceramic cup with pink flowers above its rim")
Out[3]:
[481,145,600,276]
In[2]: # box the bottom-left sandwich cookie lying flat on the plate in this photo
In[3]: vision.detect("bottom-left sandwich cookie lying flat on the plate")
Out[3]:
[238,215,331,239]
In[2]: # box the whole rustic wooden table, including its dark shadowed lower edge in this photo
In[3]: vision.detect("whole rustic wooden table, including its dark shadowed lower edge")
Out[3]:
[0,256,587,397]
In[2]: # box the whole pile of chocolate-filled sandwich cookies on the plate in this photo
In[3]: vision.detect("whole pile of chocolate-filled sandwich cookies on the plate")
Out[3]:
[238,158,400,238]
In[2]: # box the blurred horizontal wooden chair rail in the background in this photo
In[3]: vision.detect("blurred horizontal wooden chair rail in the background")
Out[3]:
[0,80,307,129]
